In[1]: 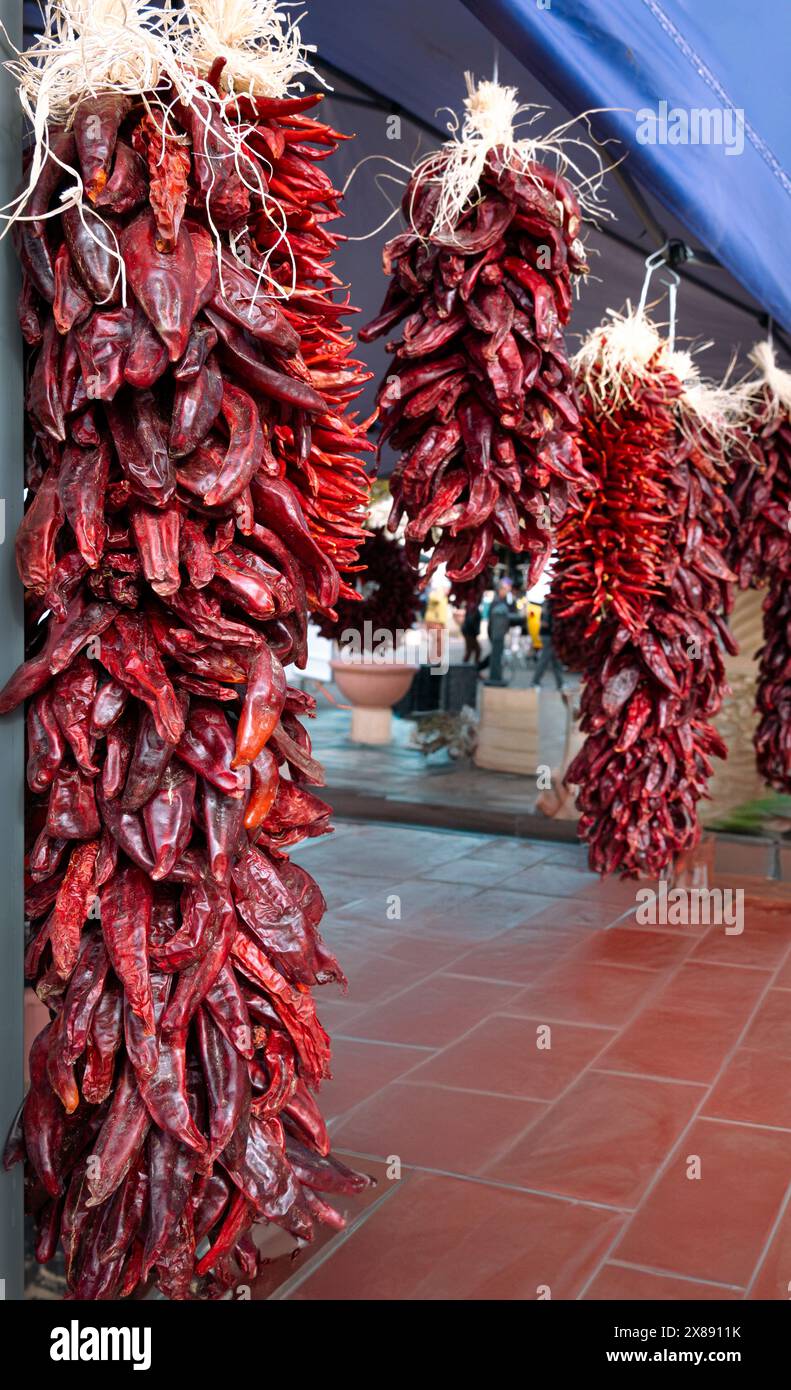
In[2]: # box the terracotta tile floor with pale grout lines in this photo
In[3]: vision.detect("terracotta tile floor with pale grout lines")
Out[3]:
[254,823,791,1301]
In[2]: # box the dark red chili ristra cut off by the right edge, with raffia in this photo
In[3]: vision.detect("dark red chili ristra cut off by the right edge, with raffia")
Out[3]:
[728,343,791,792]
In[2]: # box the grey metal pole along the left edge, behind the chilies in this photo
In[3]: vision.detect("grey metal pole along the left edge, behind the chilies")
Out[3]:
[0,0,24,1298]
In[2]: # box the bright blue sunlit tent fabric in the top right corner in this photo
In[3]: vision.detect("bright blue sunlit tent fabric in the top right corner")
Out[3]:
[464,0,791,329]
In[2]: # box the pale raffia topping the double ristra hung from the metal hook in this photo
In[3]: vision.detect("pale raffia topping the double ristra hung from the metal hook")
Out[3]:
[571,304,742,441]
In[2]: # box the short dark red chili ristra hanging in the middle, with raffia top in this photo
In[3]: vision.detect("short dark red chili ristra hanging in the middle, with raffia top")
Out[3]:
[360,79,588,594]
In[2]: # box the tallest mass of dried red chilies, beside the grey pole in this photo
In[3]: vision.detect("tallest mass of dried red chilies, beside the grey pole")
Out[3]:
[0,2,368,1298]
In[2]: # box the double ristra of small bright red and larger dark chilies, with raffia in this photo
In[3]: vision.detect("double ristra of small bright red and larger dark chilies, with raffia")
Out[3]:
[553,317,733,876]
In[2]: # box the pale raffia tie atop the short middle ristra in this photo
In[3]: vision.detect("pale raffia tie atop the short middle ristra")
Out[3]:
[405,72,610,246]
